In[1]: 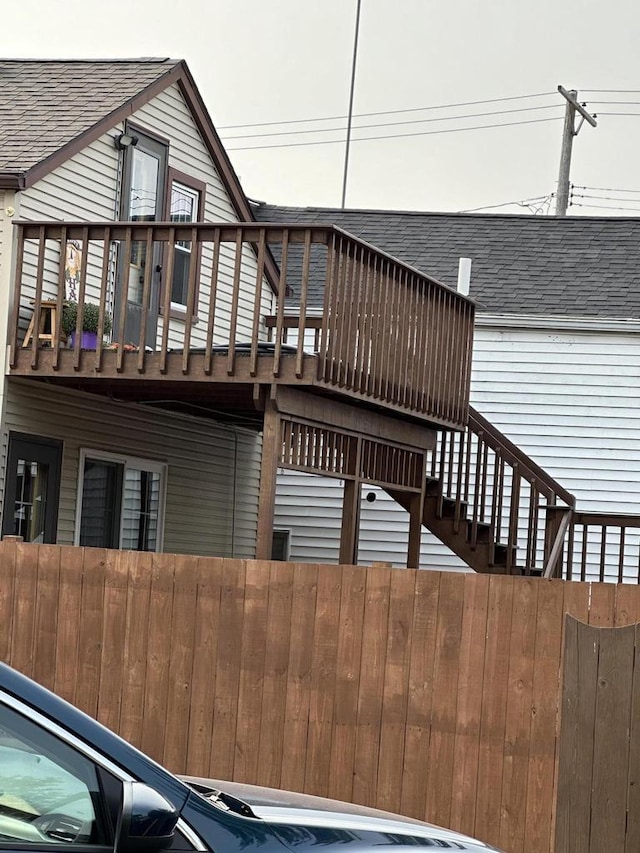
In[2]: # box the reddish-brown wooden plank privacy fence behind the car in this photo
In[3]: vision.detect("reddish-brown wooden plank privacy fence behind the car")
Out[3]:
[0,541,640,853]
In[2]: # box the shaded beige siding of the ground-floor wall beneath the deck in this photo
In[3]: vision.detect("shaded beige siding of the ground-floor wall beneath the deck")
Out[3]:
[3,380,260,558]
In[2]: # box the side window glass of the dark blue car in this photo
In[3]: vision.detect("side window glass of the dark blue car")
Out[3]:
[0,704,109,849]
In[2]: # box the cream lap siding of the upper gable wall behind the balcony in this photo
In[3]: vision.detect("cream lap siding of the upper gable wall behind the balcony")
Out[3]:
[16,85,273,347]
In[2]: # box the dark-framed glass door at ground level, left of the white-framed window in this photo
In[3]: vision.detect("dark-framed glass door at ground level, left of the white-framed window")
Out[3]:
[2,432,62,543]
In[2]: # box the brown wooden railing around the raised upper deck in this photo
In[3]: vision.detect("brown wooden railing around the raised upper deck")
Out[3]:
[9,222,474,426]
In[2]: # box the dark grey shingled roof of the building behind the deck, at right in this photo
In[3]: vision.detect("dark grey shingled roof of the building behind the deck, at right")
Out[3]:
[254,204,640,319]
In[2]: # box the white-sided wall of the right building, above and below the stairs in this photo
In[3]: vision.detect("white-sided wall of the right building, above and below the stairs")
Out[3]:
[275,319,640,569]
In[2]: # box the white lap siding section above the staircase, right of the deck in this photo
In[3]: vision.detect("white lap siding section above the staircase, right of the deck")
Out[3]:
[471,327,640,513]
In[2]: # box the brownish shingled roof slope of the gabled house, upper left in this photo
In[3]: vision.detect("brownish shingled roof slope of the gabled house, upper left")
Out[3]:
[0,59,182,187]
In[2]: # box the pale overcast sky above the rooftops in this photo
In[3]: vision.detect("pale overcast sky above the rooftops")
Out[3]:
[5,0,640,216]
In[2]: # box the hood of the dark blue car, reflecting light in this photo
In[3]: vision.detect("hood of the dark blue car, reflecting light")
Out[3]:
[180,776,496,851]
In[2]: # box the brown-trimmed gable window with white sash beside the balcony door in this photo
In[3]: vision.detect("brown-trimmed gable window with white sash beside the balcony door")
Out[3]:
[169,169,205,316]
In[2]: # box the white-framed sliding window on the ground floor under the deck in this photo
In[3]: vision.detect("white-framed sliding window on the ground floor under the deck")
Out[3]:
[76,450,166,551]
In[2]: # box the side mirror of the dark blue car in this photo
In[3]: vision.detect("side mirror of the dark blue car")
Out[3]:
[114,782,180,853]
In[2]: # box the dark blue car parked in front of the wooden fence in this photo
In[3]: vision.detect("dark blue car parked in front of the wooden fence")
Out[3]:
[0,664,500,853]
